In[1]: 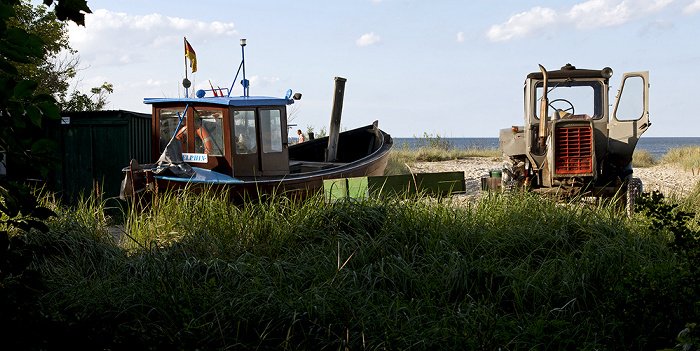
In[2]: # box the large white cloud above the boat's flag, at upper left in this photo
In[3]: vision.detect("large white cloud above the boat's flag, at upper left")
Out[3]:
[69,9,238,65]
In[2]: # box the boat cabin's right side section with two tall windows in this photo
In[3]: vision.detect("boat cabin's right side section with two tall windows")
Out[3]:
[230,106,289,177]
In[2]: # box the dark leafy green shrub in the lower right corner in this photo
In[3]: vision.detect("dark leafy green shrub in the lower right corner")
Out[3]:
[611,192,700,349]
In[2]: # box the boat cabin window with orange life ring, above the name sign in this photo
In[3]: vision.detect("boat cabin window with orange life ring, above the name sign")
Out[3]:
[194,109,224,156]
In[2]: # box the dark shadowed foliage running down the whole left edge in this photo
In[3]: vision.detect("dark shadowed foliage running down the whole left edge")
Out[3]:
[0,0,90,349]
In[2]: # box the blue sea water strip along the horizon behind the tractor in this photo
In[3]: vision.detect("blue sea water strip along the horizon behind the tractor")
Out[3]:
[394,136,700,160]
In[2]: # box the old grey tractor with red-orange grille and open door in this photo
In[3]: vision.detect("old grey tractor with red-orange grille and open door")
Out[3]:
[499,64,651,211]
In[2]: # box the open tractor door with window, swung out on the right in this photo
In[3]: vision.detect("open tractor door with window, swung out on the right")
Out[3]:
[608,72,650,167]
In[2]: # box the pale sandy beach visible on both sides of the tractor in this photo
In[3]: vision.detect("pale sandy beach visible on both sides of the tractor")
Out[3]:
[411,157,700,195]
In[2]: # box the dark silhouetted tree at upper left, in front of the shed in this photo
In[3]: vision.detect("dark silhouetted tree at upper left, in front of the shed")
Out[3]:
[0,0,90,212]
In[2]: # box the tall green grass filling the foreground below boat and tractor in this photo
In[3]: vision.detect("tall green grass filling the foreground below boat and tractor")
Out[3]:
[17,192,688,350]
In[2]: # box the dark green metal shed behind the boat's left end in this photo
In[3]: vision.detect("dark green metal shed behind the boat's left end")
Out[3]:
[47,110,152,204]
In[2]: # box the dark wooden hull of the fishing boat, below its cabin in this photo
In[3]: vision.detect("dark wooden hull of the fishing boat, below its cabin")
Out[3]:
[154,125,393,200]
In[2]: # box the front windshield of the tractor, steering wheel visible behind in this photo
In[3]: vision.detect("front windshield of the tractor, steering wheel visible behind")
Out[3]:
[535,80,603,119]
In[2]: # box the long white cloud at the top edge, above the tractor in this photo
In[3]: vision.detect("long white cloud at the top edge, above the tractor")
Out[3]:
[486,0,672,42]
